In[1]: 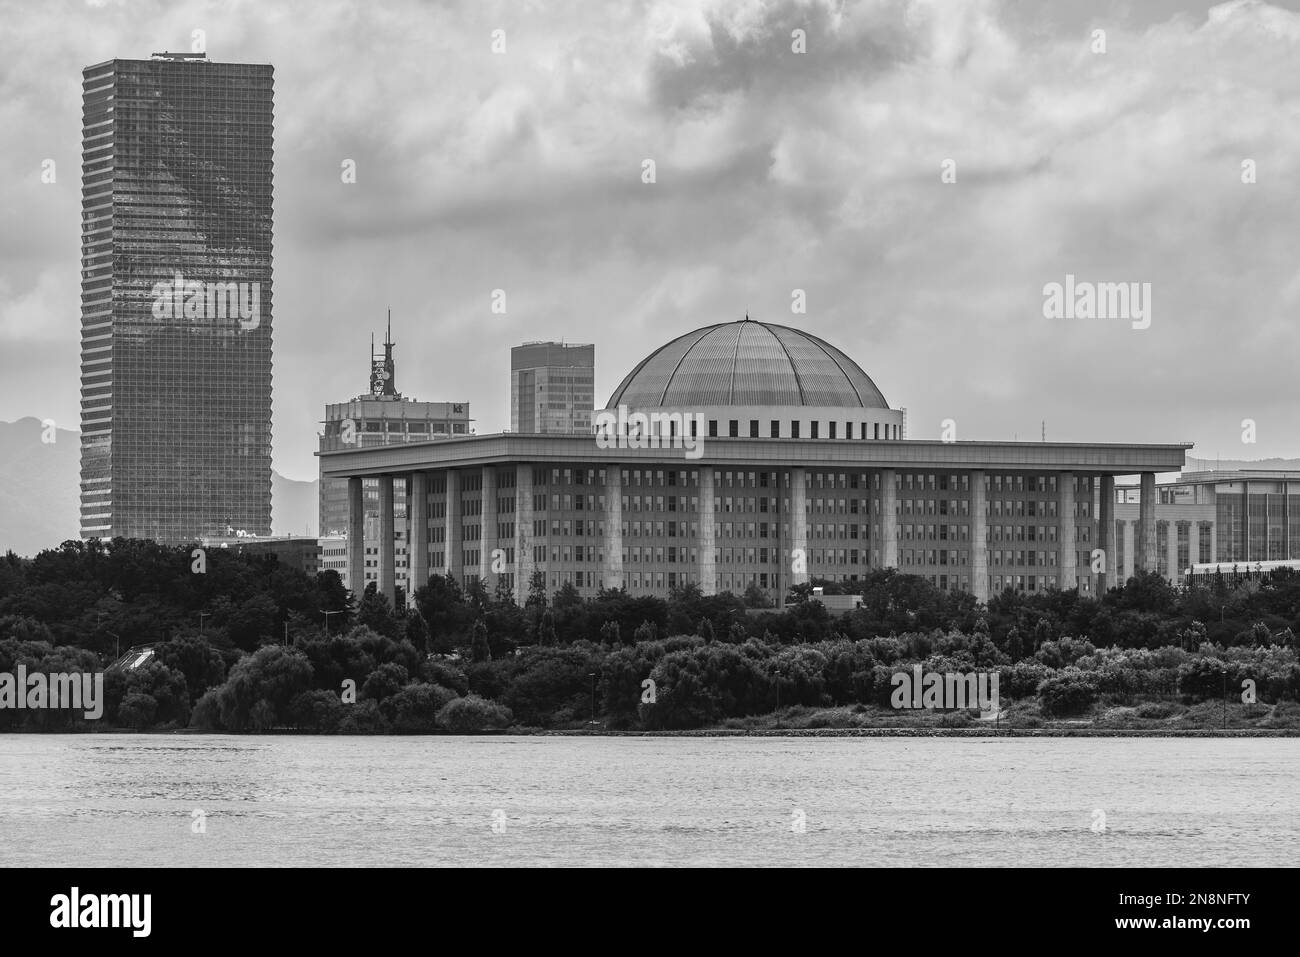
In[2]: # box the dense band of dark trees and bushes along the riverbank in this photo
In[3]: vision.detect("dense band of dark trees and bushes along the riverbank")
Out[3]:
[0,538,1300,732]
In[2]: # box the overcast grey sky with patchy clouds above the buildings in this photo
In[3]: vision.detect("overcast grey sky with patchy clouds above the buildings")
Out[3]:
[0,0,1300,479]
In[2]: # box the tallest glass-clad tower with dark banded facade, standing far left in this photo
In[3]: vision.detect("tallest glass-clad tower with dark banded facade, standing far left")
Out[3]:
[81,53,273,544]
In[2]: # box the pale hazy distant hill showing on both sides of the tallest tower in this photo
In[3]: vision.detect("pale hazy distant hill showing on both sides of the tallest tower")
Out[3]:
[0,419,317,555]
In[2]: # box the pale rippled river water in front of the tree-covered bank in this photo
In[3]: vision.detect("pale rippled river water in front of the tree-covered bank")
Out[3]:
[0,735,1300,866]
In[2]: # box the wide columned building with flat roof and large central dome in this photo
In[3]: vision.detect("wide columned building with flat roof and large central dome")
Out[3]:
[320,316,1197,603]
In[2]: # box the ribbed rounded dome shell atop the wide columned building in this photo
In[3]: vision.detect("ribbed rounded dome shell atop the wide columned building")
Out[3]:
[606,317,889,408]
